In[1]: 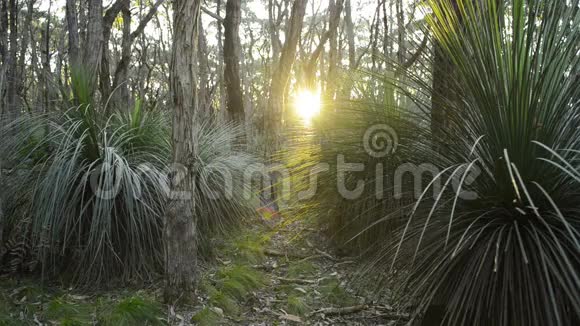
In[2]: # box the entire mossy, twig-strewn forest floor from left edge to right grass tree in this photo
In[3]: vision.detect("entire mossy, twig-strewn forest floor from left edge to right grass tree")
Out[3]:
[0,215,407,325]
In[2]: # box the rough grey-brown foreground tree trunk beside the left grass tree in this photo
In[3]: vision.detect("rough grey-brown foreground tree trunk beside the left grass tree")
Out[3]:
[165,0,201,302]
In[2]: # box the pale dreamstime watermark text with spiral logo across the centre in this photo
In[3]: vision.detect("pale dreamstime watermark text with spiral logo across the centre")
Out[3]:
[90,124,481,201]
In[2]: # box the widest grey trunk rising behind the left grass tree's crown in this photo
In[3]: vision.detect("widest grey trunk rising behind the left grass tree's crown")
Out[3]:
[83,0,106,95]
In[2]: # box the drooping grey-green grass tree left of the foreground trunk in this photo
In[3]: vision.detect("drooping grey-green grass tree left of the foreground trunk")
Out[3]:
[0,104,169,285]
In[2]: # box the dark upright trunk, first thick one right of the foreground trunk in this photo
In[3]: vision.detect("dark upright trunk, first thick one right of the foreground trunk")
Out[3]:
[224,0,245,124]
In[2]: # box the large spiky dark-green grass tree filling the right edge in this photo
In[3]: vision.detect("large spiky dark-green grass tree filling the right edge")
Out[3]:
[362,0,580,326]
